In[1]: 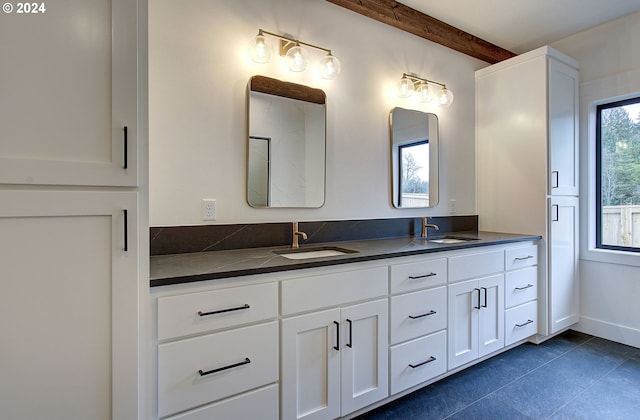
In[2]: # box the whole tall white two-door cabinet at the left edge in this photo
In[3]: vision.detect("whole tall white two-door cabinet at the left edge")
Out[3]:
[0,0,148,419]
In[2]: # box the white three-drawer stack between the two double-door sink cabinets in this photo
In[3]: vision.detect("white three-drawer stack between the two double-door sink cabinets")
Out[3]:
[389,257,447,394]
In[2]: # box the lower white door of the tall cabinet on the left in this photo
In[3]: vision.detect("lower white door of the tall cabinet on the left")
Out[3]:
[0,191,139,420]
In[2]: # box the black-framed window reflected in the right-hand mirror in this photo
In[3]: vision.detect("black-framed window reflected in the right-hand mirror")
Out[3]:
[398,140,429,207]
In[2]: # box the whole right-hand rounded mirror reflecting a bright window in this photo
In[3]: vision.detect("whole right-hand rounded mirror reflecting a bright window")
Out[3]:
[389,108,438,208]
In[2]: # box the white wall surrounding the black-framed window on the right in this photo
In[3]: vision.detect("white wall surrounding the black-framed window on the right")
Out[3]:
[553,13,640,347]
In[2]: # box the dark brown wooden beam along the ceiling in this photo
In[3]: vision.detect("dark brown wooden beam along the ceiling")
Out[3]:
[327,0,516,64]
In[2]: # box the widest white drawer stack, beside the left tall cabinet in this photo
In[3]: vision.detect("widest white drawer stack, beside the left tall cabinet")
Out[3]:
[157,282,279,419]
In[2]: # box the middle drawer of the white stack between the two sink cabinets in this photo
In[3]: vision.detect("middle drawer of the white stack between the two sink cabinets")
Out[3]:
[391,286,447,344]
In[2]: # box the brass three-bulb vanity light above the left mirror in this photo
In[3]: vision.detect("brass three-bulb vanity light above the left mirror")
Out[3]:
[249,29,340,80]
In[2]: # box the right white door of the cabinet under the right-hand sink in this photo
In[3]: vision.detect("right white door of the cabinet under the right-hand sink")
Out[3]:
[478,274,504,357]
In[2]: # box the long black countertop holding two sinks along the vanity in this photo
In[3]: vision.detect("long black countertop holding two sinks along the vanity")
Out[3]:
[150,232,541,287]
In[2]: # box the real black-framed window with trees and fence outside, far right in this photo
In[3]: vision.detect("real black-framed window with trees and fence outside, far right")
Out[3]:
[596,97,640,252]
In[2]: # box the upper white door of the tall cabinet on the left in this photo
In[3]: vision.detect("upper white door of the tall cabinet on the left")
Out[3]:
[0,0,138,186]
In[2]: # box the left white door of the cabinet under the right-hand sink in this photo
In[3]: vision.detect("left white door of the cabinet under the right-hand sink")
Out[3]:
[447,280,480,369]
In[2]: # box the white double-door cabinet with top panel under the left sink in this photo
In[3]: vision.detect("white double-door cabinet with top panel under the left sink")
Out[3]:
[281,266,389,419]
